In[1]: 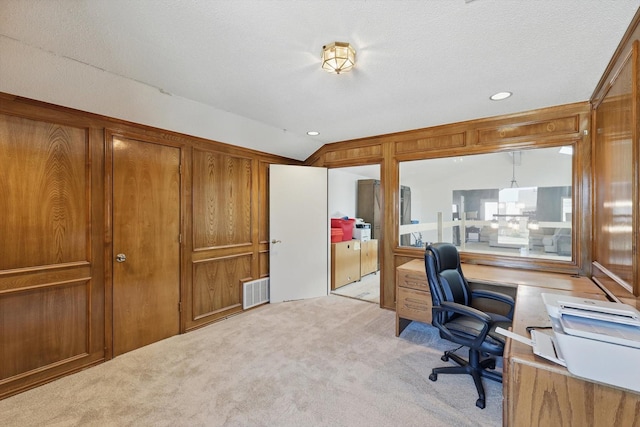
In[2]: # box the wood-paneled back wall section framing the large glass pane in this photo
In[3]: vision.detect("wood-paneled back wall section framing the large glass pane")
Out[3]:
[305,102,591,309]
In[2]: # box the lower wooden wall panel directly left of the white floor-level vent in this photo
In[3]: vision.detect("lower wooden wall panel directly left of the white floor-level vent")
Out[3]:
[192,254,252,320]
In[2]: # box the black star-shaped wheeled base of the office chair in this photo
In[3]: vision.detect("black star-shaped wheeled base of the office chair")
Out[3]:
[429,349,502,409]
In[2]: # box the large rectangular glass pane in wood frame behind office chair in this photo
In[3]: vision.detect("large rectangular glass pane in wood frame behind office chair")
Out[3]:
[399,145,573,261]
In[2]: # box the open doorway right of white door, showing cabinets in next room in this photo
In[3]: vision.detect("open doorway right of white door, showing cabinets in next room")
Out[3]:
[328,164,382,305]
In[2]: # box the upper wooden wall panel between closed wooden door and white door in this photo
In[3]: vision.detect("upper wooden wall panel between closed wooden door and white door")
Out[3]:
[192,149,253,250]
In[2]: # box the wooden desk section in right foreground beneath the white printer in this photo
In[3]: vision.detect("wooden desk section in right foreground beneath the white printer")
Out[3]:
[502,285,640,427]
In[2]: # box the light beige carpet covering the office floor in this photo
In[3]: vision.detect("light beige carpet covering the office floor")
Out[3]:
[0,295,502,427]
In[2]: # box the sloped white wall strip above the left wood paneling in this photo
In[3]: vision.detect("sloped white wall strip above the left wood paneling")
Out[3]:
[0,36,322,160]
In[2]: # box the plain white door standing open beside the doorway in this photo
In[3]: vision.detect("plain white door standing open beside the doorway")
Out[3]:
[269,165,329,303]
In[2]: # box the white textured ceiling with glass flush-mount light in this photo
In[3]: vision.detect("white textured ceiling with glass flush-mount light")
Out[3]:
[0,0,640,159]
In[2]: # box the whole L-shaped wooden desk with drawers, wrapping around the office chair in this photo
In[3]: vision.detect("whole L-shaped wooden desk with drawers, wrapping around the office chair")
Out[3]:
[396,260,640,427]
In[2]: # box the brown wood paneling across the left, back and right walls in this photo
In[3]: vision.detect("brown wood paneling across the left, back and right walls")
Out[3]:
[0,7,640,398]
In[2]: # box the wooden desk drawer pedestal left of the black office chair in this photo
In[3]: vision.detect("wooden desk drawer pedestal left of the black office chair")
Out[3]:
[396,260,432,336]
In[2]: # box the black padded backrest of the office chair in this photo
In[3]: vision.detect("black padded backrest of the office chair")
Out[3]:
[424,243,471,322]
